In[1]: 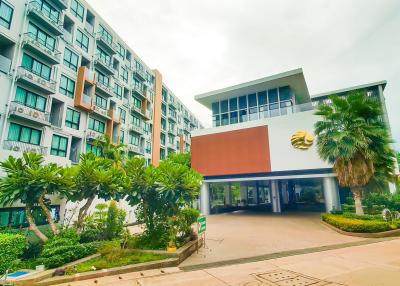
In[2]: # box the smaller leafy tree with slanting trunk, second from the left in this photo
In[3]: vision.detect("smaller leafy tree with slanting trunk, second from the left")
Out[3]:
[68,152,129,228]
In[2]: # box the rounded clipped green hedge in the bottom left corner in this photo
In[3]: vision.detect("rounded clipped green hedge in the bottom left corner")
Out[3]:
[0,233,26,274]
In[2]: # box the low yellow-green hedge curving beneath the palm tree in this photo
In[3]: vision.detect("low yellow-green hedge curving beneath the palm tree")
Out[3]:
[322,214,397,233]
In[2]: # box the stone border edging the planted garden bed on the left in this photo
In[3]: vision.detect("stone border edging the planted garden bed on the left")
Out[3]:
[14,239,203,286]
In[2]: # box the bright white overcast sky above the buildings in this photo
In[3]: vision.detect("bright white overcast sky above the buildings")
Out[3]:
[88,0,400,150]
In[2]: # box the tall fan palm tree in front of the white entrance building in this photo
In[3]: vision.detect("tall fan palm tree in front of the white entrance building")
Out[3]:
[315,92,394,215]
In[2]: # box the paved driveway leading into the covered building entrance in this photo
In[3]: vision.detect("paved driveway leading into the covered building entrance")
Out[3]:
[180,212,365,269]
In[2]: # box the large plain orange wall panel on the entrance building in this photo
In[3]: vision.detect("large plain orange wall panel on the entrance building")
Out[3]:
[191,126,271,176]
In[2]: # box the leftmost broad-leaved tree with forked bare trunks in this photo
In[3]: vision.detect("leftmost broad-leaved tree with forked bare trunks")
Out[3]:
[0,153,72,241]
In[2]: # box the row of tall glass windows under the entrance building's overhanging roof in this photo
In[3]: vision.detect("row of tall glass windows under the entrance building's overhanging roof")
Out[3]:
[212,86,294,127]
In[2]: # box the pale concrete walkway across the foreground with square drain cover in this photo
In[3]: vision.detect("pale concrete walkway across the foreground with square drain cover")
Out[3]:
[57,239,400,286]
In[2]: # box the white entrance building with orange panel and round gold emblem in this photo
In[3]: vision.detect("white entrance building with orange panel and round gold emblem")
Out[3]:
[192,69,396,214]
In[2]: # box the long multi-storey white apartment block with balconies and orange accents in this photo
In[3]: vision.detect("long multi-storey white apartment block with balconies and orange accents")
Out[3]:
[0,0,200,226]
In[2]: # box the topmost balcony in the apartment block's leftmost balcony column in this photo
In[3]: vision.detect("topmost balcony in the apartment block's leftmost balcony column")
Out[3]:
[27,1,64,36]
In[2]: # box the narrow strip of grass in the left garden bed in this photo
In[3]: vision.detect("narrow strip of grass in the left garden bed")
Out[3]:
[67,250,168,275]
